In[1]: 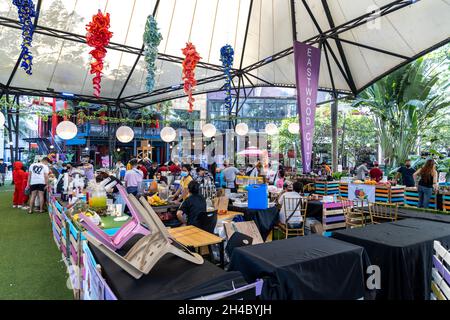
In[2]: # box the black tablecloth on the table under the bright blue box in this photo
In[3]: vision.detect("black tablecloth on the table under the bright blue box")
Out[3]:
[228,205,280,241]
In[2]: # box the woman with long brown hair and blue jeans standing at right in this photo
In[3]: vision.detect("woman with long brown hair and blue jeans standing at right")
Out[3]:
[413,159,438,208]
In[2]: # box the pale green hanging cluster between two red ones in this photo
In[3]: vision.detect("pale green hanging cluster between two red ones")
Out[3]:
[144,15,162,93]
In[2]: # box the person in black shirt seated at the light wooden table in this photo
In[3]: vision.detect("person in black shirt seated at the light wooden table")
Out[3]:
[177,181,206,228]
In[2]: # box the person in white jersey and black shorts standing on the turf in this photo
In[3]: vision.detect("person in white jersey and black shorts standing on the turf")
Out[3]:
[27,157,51,214]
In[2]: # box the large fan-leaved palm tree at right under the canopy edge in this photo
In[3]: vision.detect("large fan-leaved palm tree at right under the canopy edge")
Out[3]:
[353,58,450,166]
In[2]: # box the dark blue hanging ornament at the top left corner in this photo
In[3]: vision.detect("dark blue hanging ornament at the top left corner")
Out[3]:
[13,0,36,75]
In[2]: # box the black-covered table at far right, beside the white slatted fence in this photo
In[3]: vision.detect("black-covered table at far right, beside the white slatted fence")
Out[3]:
[333,219,450,300]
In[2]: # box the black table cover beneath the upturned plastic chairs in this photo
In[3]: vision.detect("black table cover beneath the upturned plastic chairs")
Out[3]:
[89,244,247,300]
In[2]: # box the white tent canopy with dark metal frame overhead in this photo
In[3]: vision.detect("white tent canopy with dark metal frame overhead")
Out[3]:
[0,0,450,108]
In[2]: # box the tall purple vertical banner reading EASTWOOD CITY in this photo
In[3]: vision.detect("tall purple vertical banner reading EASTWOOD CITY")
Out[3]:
[294,41,320,173]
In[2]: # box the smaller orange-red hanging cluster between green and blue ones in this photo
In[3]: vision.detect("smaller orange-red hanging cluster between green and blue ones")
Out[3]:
[182,42,201,112]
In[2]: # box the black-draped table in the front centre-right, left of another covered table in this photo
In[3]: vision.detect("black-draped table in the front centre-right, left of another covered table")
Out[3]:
[230,235,370,300]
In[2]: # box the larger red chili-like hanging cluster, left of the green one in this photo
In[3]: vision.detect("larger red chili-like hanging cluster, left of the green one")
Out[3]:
[86,10,113,98]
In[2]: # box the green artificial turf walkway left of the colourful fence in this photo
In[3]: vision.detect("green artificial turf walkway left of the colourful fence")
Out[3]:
[0,185,73,300]
